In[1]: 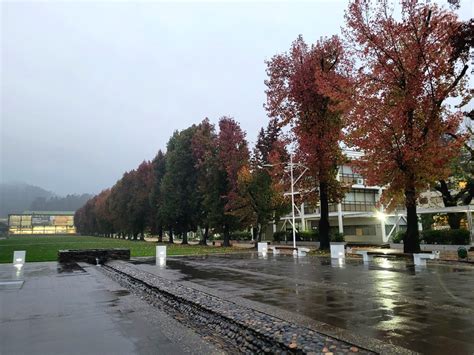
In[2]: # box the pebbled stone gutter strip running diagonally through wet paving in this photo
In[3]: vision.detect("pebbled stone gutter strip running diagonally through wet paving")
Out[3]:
[104,261,373,354]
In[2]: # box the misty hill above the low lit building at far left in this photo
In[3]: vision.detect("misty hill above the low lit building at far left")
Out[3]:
[0,183,92,218]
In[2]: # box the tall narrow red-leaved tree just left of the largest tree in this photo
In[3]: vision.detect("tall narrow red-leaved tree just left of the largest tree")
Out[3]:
[265,36,349,249]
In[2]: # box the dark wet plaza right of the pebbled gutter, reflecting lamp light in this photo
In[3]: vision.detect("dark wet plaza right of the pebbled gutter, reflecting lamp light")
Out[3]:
[131,254,474,354]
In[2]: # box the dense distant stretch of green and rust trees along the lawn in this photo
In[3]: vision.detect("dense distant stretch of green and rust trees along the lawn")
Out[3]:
[74,117,289,246]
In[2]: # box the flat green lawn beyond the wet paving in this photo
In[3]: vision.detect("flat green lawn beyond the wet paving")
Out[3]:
[0,236,242,263]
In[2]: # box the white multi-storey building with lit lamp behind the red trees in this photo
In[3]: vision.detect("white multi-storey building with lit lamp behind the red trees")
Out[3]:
[267,150,474,244]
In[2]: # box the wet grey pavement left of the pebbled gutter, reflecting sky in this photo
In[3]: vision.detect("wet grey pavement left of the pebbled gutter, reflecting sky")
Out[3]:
[0,263,218,355]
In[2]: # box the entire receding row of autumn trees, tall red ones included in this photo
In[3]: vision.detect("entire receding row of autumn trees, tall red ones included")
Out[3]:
[76,0,468,252]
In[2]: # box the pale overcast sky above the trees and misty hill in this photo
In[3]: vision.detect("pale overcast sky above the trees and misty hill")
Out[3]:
[0,0,469,194]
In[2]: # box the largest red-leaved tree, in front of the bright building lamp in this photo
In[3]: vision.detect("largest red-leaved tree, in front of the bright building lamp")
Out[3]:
[346,0,468,253]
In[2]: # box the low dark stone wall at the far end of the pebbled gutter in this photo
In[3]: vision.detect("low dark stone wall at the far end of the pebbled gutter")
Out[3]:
[58,248,130,264]
